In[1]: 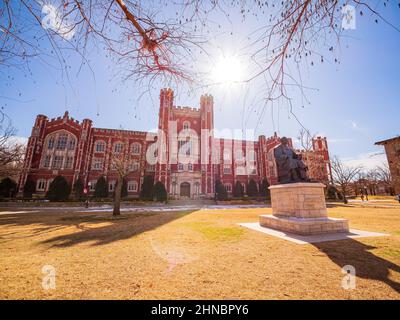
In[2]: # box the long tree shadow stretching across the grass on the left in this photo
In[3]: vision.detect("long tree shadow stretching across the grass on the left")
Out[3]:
[0,211,194,247]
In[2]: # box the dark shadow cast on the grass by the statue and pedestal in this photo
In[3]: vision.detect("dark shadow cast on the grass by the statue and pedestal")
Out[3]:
[312,239,400,292]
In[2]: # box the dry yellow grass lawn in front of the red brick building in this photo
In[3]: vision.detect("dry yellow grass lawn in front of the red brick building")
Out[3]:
[0,206,400,299]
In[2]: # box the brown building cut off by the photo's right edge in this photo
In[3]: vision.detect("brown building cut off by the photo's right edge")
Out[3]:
[375,136,400,194]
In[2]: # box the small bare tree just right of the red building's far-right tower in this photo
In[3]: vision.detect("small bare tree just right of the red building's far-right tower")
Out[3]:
[332,156,362,203]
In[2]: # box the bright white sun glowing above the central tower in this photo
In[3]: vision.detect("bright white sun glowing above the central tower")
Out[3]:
[212,56,244,84]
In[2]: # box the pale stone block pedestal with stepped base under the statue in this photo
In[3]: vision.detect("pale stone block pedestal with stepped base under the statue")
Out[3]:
[260,183,349,235]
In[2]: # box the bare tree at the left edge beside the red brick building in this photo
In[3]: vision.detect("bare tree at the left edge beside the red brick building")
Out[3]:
[0,112,25,177]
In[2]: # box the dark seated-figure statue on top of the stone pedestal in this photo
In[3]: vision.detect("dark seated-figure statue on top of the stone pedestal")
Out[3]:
[274,137,310,183]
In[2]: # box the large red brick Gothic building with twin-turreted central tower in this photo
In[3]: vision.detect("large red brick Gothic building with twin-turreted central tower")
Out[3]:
[19,89,330,198]
